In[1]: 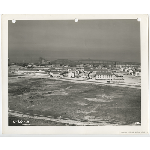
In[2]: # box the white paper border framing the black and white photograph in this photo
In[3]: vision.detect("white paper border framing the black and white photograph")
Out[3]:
[1,14,149,135]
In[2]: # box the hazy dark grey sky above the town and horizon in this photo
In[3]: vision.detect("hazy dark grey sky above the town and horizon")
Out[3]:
[8,19,140,62]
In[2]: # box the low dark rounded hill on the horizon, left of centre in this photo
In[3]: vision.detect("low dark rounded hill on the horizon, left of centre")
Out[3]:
[51,59,79,66]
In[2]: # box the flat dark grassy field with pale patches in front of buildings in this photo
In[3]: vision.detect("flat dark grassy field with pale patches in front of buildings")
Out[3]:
[8,77,141,126]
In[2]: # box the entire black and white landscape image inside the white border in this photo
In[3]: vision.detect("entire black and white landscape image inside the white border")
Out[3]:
[1,14,148,133]
